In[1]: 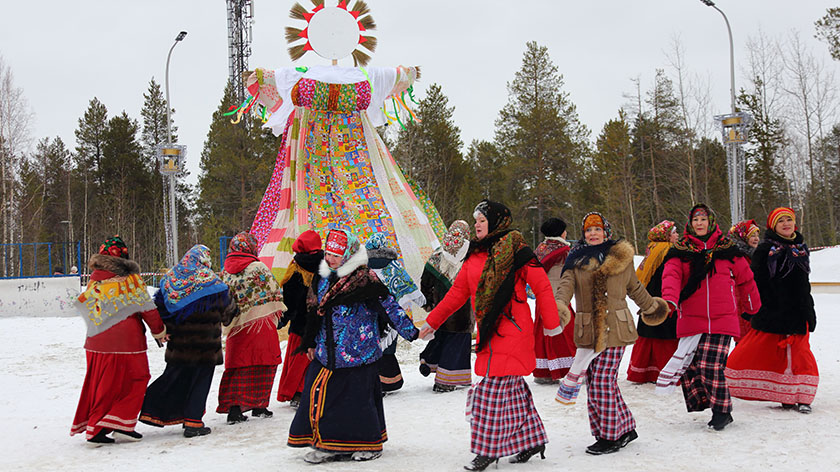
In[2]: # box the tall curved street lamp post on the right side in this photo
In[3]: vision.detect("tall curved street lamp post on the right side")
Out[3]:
[700,0,753,224]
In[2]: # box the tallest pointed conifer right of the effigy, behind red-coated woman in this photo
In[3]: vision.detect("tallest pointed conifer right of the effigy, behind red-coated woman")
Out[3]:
[495,42,589,240]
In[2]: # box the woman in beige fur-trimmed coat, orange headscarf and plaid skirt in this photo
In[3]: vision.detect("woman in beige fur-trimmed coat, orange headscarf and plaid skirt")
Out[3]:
[555,212,669,455]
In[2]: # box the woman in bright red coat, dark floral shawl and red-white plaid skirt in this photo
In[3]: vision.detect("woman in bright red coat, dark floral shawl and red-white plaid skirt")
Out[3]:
[421,200,562,470]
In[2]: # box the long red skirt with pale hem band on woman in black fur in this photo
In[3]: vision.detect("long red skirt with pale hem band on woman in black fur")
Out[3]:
[725,329,820,405]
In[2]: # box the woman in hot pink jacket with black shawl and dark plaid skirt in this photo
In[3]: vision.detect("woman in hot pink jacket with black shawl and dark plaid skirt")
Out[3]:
[656,204,761,431]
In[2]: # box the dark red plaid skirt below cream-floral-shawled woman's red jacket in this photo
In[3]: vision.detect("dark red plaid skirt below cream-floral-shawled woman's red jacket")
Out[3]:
[216,365,277,413]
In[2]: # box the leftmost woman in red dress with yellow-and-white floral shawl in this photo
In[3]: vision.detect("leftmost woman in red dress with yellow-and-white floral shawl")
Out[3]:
[70,249,166,440]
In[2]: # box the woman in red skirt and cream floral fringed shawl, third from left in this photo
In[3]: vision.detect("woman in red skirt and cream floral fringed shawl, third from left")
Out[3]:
[216,233,286,413]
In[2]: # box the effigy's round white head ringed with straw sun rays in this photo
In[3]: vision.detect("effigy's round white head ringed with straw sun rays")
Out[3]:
[286,0,376,66]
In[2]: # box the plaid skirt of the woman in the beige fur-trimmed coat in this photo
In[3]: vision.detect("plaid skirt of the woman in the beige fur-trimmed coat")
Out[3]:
[586,346,636,441]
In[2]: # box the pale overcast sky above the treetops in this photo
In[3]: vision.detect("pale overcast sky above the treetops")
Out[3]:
[0,0,840,186]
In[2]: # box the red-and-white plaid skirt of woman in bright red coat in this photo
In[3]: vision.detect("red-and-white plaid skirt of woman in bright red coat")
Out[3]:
[467,375,548,457]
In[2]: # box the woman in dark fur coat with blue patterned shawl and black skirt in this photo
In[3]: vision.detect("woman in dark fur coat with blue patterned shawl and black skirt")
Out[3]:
[140,245,239,428]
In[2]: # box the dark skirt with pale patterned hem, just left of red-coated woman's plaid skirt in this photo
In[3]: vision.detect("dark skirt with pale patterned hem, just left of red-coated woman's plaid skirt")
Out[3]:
[420,330,472,386]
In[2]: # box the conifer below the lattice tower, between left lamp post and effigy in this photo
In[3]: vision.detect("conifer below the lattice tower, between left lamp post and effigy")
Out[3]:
[196,83,280,247]
